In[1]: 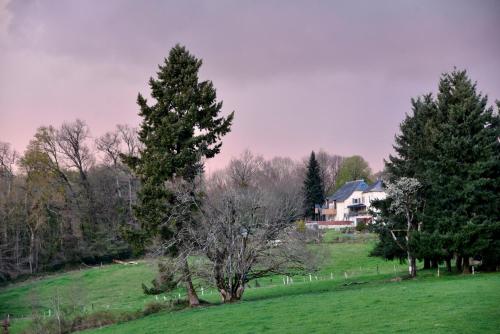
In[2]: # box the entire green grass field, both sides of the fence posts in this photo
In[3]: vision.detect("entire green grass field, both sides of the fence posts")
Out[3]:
[0,232,500,333]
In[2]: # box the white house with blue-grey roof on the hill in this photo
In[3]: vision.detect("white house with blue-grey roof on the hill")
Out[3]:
[318,180,386,225]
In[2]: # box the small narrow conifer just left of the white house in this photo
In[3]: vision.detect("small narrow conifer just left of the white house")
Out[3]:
[303,151,325,217]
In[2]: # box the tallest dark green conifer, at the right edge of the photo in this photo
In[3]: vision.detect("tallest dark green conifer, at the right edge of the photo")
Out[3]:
[428,71,500,272]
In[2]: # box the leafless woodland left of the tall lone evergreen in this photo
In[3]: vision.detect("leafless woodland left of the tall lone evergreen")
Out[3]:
[0,120,139,281]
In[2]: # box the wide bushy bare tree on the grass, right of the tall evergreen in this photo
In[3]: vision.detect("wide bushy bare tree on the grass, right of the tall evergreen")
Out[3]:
[191,152,313,302]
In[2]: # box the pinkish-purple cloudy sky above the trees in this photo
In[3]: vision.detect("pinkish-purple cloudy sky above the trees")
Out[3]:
[0,0,500,171]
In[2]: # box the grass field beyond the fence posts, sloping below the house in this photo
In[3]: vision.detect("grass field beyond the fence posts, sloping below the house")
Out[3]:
[0,231,405,318]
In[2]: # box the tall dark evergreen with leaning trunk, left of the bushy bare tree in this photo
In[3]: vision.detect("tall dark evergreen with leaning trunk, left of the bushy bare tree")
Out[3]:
[125,45,233,305]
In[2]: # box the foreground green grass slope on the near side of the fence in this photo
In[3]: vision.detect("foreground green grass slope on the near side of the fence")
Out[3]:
[85,274,500,334]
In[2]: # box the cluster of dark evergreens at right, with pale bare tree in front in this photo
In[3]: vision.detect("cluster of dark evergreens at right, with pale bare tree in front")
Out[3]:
[373,70,500,276]
